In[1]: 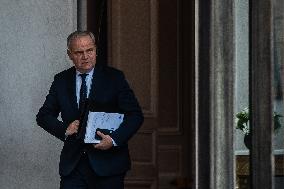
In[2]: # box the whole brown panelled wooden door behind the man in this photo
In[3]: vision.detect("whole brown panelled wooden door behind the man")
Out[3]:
[88,0,195,189]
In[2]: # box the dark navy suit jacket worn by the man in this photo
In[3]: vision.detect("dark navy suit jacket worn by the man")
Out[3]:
[37,66,144,176]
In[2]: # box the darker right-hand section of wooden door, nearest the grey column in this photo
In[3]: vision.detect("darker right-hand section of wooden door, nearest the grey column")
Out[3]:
[157,0,195,189]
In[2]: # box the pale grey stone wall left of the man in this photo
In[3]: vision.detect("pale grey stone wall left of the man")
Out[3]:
[0,0,76,189]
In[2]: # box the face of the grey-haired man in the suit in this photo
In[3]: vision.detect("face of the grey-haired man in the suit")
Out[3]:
[68,36,96,73]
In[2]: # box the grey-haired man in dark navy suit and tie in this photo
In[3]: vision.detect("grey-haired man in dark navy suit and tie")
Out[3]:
[37,31,143,189]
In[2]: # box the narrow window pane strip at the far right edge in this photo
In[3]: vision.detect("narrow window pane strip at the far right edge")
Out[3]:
[273,0,284,189]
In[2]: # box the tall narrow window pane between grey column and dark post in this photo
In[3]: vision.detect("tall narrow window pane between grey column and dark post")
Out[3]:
[235,0,249,189]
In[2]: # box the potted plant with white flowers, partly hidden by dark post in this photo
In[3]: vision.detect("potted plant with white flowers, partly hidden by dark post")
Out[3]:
[236,108,283,149]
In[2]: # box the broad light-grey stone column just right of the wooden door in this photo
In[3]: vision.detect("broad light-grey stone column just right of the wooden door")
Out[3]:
[196,0,235,189]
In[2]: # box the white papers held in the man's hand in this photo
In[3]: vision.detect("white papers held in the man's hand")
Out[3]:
[84,112,124,143]
